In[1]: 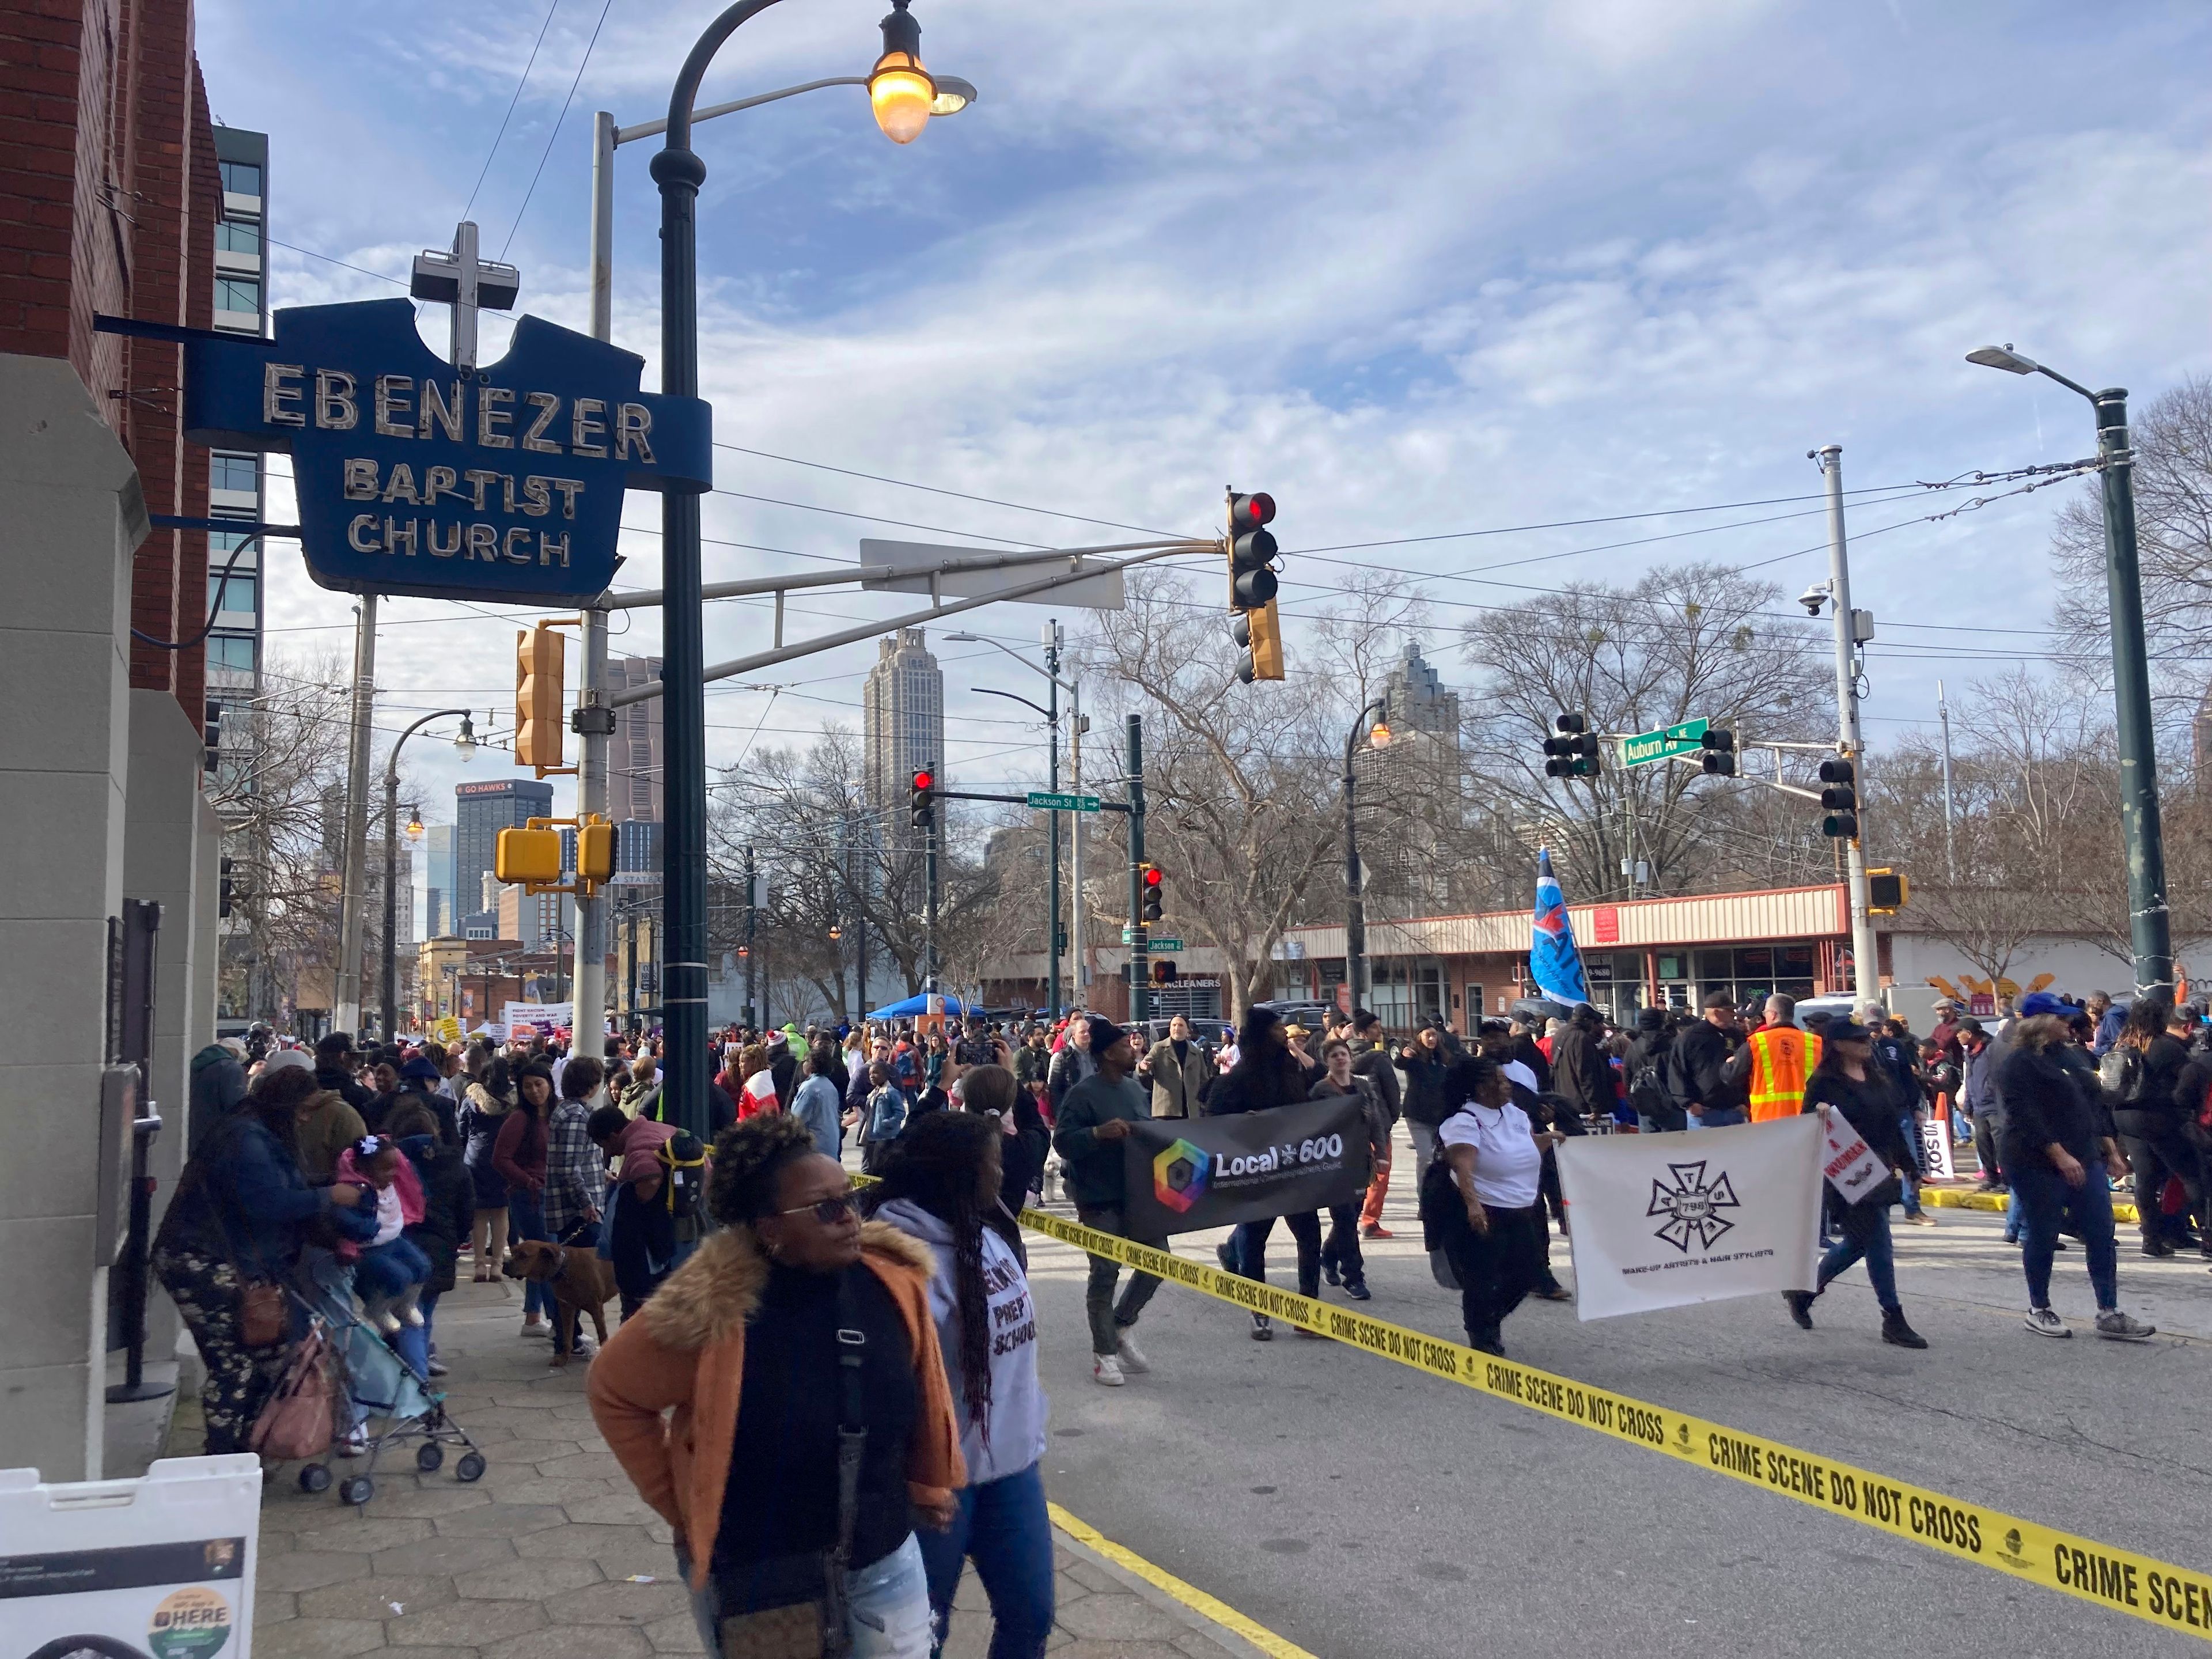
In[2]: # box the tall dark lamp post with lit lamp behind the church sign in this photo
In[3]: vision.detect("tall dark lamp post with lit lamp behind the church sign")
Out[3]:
[650,0,973,1135]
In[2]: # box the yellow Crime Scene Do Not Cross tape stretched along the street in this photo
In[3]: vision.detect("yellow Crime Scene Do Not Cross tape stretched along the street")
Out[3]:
[1022,1210,2212,1641]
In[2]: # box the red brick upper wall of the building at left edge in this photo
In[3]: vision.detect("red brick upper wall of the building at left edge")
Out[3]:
[0,0,221,728]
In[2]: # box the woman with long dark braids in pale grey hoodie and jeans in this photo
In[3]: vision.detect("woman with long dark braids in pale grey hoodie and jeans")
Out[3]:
[869,1110,1053,1659]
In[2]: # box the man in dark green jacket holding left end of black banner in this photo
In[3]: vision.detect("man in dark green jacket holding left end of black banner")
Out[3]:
[1053,1016,1168,1389]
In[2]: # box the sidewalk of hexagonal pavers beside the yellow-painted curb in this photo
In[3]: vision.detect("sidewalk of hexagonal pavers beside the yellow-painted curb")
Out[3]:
[203,1283,1296,1659]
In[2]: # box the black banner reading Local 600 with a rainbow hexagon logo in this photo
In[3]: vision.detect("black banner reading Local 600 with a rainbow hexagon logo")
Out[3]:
[1124,1095,1369,1238]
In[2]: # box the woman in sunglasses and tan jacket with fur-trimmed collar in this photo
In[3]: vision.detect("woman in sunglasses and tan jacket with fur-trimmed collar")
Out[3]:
[588,1113,967,1659]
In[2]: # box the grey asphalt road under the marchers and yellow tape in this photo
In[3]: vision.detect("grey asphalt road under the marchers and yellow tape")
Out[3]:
[1013,1135,2212,1659]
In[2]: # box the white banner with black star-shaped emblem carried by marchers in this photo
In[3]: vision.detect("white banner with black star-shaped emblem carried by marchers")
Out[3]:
[1559,1117,1820,1319]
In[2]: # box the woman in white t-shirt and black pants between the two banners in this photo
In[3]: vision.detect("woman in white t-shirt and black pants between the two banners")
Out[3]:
[1435,1055,1557,1354]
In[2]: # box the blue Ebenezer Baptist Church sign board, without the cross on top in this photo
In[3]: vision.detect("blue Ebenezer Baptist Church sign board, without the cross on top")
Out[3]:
[184,298,714,604]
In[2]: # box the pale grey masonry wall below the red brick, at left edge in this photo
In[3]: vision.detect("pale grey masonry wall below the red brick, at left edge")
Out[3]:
[0,354,149,1480]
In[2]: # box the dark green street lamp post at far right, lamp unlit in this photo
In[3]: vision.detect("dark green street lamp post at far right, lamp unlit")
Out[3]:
[1967,345,2175,995]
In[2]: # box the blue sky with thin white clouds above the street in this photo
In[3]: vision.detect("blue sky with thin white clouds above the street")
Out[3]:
[199,0,2212,836]
